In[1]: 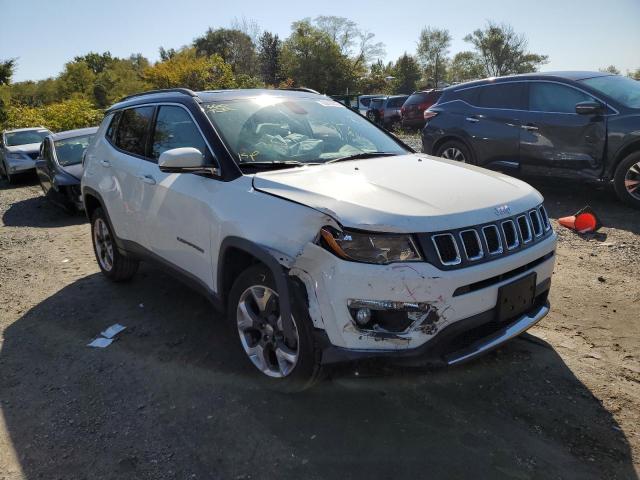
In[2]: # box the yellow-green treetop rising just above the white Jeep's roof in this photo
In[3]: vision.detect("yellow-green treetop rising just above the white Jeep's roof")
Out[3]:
[142,48,235,90]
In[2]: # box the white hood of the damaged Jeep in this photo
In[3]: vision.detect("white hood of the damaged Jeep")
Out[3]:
[253,154,542,233]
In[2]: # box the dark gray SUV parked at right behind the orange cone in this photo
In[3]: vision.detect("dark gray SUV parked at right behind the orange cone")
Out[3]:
[422,72,640,208]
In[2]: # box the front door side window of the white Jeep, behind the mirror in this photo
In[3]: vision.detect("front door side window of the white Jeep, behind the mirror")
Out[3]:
[151,106,207,160]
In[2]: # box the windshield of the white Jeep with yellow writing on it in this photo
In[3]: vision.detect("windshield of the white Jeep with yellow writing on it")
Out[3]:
[204,95,408,164]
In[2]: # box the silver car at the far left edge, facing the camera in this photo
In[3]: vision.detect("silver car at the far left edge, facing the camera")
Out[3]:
[0,127,51,183]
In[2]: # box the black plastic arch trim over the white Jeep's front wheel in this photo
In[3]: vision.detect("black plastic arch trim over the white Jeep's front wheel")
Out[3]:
[216,236,293,338]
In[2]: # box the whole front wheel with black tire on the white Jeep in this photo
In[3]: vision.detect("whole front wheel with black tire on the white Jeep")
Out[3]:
[227,264,321,392]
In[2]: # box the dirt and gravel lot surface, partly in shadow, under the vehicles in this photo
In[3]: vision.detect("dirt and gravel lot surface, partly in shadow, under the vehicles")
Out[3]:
[0,171,640,480]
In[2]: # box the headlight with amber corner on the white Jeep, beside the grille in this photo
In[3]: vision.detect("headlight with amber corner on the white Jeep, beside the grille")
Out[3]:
[320,227,422,264]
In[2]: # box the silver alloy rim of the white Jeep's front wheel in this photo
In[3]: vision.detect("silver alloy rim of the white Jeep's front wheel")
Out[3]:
[236,285,300,378]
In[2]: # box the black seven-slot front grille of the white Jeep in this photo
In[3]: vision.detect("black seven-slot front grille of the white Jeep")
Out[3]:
[417,205,551,270]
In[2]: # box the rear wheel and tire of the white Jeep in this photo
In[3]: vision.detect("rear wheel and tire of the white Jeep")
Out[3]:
[91,208,138,282]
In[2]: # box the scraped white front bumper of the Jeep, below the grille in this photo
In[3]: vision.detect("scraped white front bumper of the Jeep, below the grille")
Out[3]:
[289,234,556,365]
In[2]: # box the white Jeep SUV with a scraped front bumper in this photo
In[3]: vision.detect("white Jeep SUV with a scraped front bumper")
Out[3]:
[82,89,556,388]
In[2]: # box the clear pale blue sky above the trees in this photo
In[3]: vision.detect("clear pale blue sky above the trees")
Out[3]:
[0,0,640,82]
